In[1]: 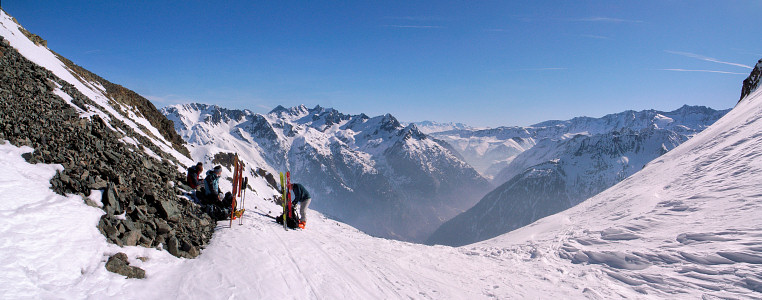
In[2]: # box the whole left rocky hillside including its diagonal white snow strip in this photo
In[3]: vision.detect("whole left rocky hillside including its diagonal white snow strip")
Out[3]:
[0,11,214,257]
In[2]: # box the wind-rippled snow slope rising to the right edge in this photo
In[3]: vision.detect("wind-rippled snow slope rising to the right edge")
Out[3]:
[474,84,762,298]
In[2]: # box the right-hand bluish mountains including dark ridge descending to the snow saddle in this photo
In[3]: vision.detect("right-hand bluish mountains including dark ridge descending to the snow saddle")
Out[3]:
[428,106,728,245]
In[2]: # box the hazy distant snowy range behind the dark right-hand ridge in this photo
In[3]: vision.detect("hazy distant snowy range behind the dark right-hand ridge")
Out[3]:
[429,105,727,180]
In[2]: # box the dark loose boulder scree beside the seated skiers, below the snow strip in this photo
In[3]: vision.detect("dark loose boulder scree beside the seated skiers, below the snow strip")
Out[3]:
[0,31,214,257]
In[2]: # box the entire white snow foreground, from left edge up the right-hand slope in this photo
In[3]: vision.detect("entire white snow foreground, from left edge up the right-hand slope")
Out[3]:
[0,85,762,299]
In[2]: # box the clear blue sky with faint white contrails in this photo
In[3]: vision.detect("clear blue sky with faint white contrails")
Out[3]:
[3,0,762,126]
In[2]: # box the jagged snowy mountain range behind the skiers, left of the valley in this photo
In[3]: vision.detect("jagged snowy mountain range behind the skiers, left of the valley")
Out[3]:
[162,104,489,241]
